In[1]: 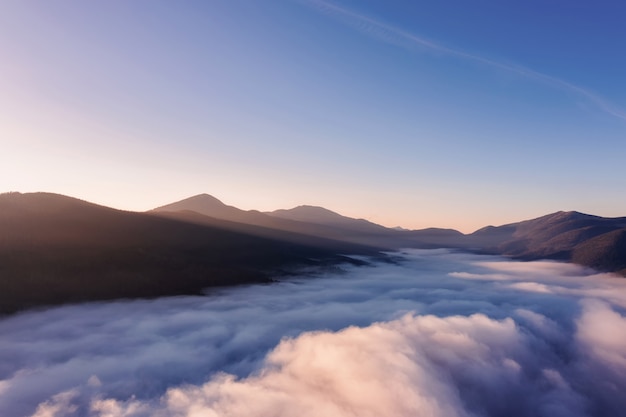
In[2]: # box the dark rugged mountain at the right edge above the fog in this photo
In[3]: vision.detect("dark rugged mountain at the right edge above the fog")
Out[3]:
[466,211,626,273]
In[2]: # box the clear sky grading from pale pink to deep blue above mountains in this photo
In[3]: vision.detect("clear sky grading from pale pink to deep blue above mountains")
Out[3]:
[0,0,626,232]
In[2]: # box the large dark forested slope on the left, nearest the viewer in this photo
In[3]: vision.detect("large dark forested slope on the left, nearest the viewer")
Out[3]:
[0,193,377,313]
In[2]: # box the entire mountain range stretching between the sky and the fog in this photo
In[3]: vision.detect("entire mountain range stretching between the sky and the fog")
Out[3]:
[0,193,626,313]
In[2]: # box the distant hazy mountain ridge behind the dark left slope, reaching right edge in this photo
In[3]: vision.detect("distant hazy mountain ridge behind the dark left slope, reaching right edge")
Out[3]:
[156,196,626,275]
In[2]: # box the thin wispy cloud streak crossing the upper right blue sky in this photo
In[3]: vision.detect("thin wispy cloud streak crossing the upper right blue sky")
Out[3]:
[299,0,626,120]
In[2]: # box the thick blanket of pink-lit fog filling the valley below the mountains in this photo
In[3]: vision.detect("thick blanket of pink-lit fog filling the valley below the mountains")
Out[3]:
[0,251,626,417]
